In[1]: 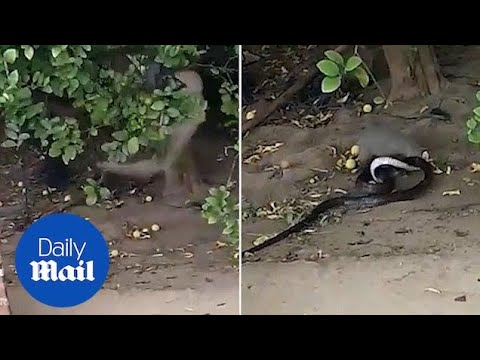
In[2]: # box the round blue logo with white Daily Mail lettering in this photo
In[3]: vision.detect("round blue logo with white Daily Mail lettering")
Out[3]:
[15,213,110,307]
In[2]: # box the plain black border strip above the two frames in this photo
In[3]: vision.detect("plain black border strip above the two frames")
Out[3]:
[0,7,478,45]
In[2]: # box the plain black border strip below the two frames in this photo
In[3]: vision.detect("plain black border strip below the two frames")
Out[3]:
[0,315,480,348]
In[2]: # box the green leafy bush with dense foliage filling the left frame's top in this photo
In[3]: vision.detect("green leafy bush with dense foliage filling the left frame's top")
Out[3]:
[0,45,238,248]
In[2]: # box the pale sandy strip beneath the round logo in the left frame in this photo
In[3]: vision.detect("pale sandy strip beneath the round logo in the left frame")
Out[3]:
[8,269,239,315]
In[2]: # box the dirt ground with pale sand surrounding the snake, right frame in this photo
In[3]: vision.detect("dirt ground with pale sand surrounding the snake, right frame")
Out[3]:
[242,46,480,314]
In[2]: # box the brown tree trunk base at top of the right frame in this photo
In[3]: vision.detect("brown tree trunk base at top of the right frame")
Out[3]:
[383,45,448,102]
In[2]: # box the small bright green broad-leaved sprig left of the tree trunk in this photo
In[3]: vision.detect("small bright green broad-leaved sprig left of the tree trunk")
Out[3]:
[316,50,370,93]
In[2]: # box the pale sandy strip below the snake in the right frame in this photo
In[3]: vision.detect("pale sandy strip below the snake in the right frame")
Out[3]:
[242,251,480,315]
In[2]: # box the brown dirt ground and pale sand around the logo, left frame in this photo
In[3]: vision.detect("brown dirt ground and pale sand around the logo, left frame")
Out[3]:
[0,125,239,315]
